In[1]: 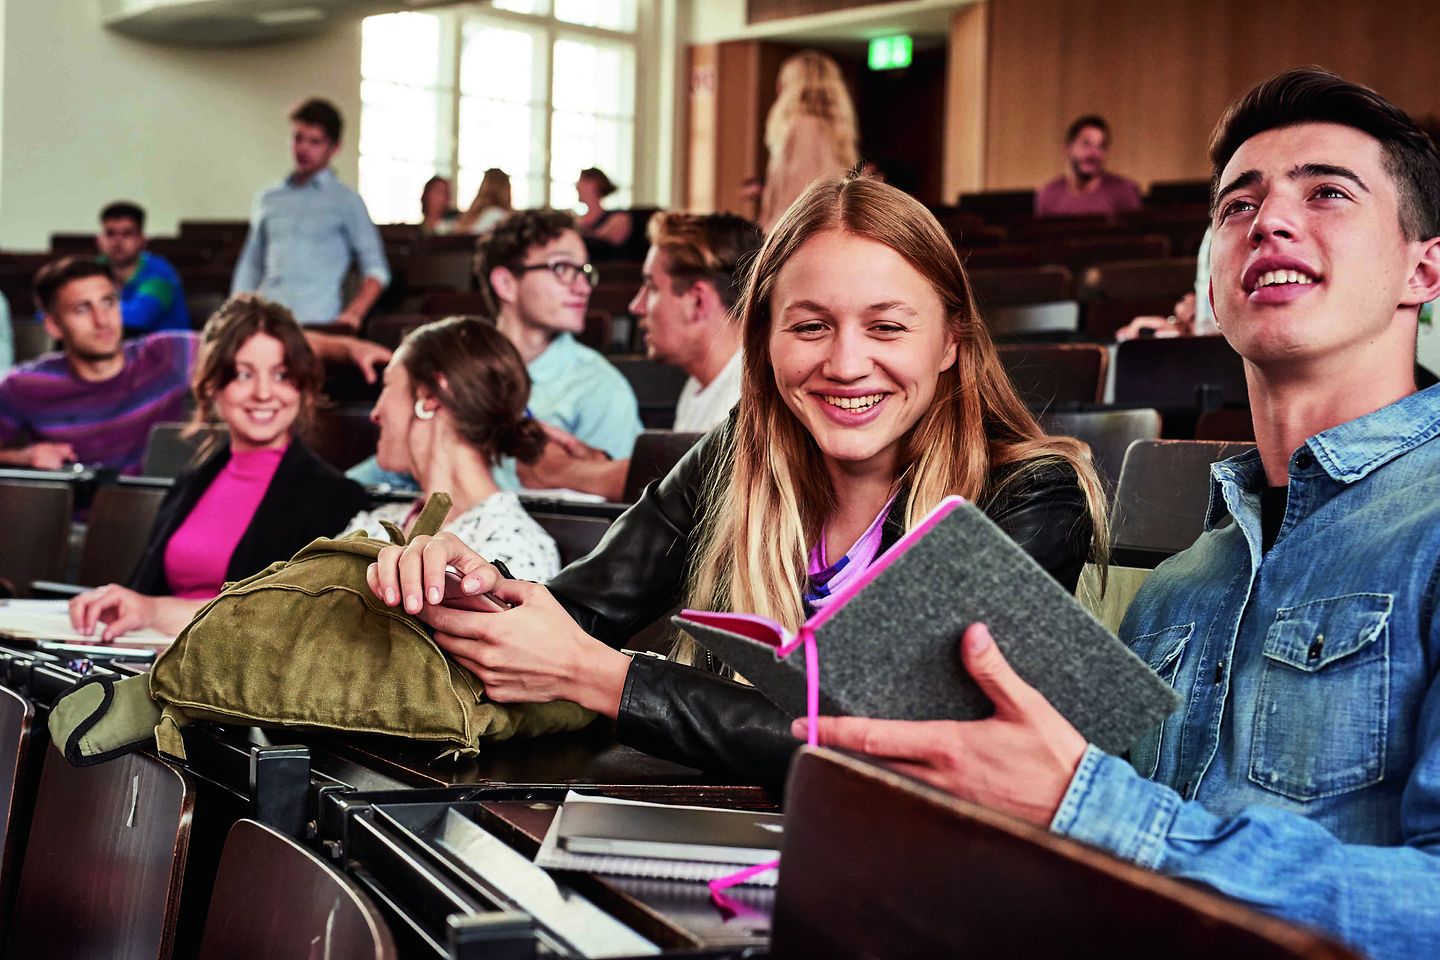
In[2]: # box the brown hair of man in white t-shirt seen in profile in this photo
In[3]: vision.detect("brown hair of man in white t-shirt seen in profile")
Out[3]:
[645,210,765,309]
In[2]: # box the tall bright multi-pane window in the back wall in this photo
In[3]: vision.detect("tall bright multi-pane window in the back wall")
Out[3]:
[360,0,636,222]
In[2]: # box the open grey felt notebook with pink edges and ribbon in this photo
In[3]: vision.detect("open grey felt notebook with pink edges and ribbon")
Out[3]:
[674,497,1179,754]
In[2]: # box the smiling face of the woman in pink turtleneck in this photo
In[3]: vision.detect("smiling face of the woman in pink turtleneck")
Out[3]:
[215,334,300,452]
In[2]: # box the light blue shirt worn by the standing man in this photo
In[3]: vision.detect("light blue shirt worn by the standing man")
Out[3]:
[230,170,390,324]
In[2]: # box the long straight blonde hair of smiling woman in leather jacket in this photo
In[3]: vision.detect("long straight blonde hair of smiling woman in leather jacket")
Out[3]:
[674,176,1107,662]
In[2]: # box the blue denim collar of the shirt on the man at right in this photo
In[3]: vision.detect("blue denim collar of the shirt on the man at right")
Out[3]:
[1205,384,1440,530]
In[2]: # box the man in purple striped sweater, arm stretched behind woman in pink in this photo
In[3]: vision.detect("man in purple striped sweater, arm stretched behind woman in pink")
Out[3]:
[0,256,390,474]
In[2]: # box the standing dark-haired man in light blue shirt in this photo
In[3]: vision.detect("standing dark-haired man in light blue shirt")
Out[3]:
[230,99,390,330]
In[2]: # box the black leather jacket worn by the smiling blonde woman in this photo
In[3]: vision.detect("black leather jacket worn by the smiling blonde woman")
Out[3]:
[547,427,1092,789]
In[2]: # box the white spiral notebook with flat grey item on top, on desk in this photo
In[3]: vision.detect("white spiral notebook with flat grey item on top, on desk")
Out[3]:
[534,790,783,887]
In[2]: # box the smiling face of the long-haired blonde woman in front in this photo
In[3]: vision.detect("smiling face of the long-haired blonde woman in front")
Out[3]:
[770,230,956,476]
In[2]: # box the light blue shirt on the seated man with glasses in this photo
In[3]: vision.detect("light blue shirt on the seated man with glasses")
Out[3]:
[495,334,645,489]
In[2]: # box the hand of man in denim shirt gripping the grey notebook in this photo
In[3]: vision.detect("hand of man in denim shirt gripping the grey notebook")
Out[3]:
[791,623,1086,826]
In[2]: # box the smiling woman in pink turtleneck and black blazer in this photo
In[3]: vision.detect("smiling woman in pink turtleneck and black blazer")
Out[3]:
[71,294,366,640]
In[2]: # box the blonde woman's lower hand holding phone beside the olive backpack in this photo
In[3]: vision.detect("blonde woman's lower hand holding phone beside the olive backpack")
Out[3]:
[420,580,629,718]
